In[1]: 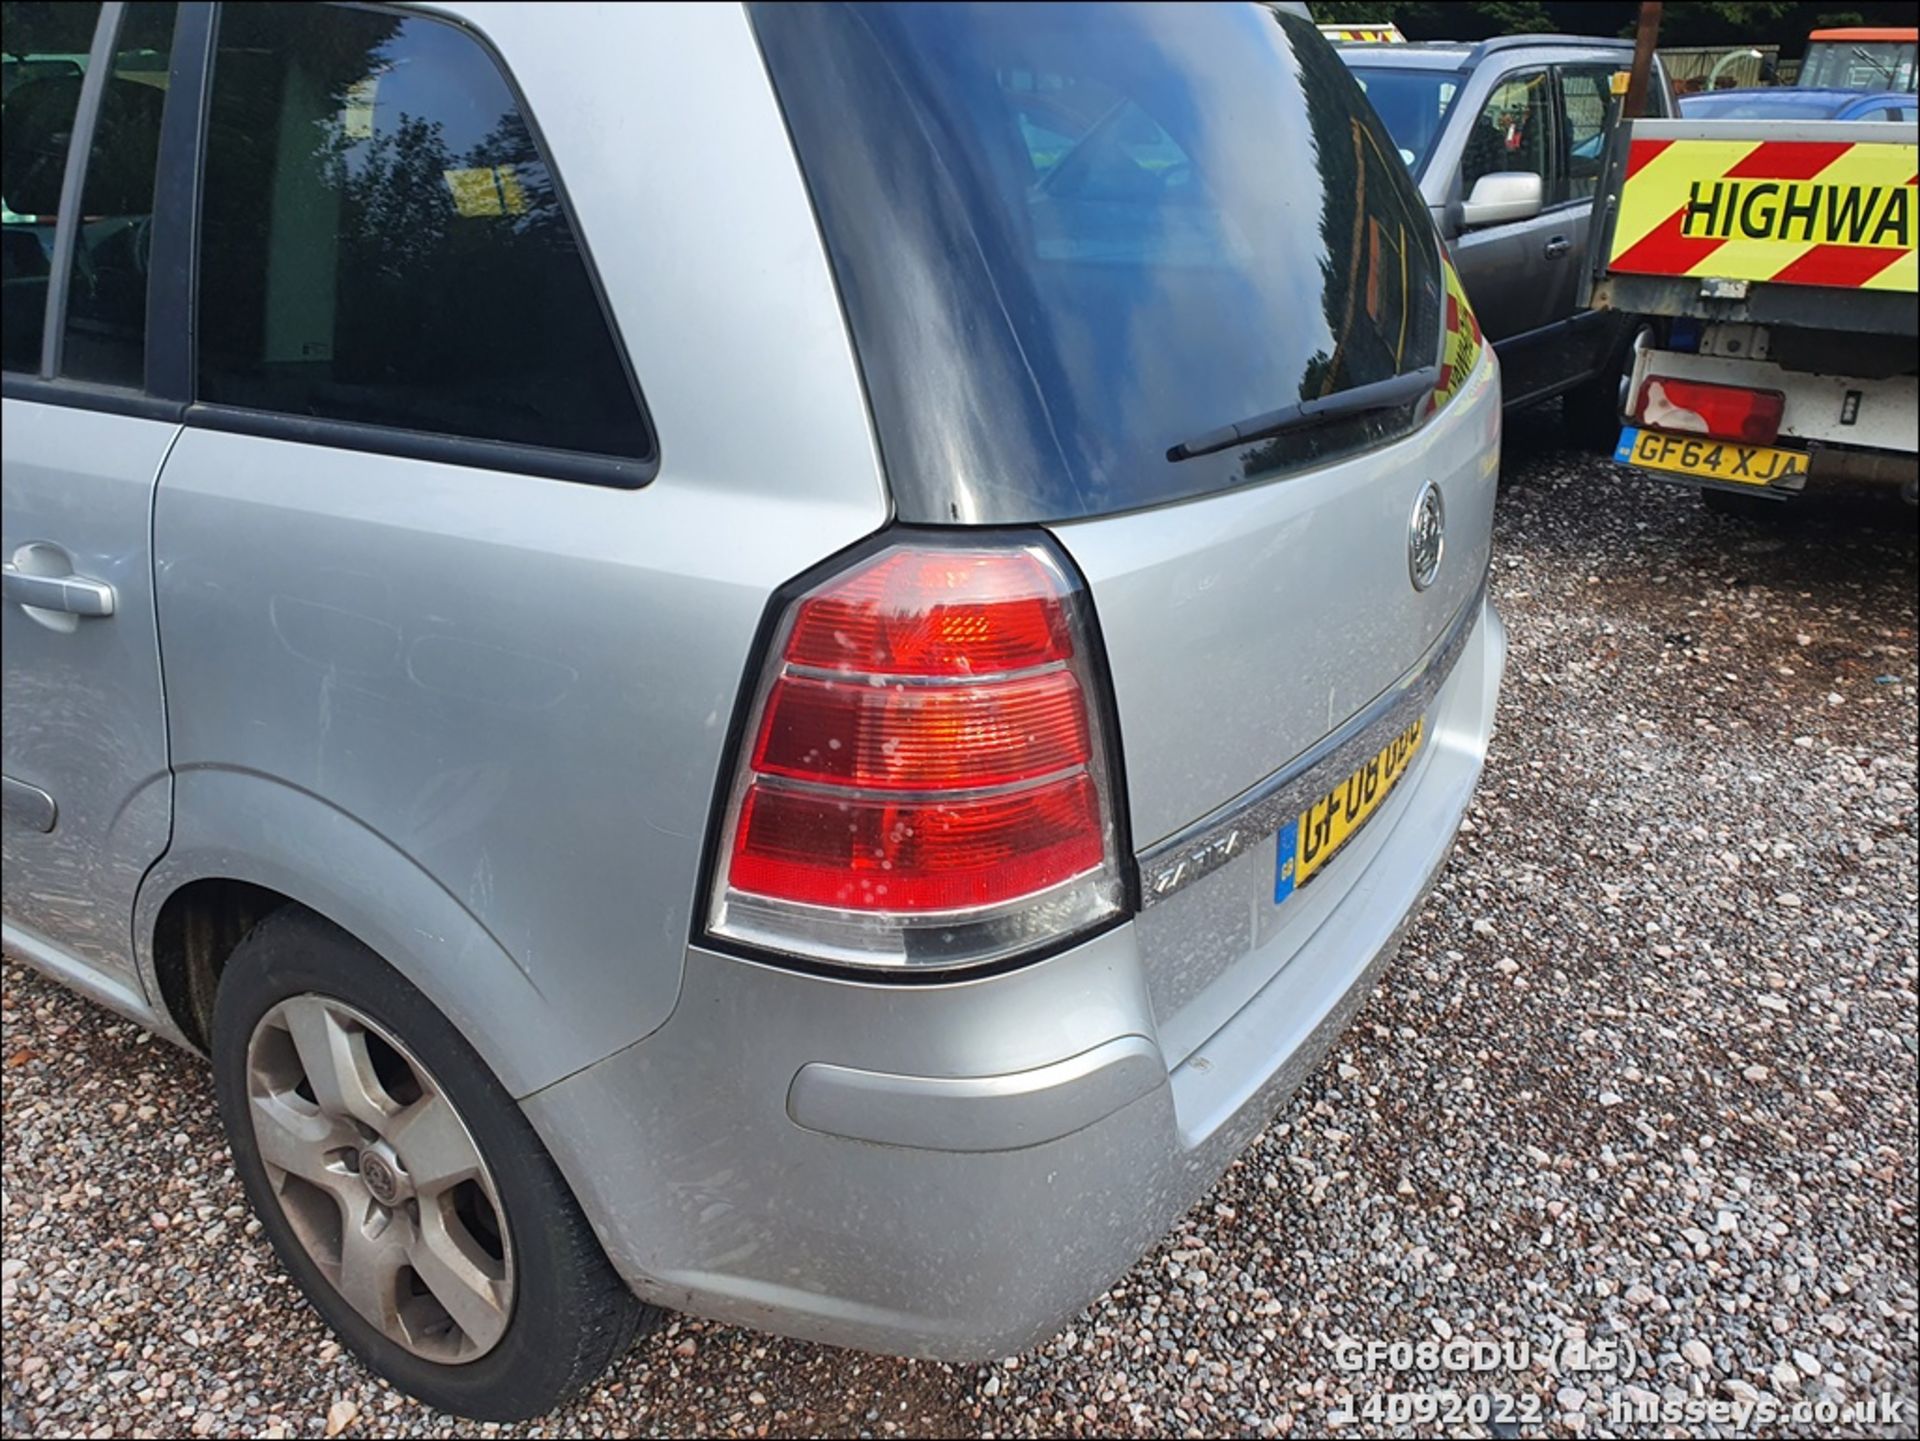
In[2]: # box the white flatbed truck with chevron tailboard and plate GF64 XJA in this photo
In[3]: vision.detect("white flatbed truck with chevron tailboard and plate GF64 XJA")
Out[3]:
[1590,119,1920,510]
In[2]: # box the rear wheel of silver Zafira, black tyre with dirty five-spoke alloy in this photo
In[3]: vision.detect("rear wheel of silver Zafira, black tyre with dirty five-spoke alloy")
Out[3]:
[211,906,651,1420]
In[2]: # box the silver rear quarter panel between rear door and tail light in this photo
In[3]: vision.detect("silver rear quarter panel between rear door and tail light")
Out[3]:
[142,6,887,1094]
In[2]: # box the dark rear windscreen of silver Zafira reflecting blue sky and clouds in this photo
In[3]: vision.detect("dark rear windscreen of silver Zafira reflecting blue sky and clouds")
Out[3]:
[753,4,1442,524]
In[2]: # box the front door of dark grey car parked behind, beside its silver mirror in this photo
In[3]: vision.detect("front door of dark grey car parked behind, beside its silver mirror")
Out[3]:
[1453,67,1572,403]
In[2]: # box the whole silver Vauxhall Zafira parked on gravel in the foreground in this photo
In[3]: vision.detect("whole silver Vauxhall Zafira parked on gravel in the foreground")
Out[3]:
[0,4,1505,1416]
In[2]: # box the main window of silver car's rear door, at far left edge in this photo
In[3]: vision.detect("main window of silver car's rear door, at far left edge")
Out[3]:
[0,0,100,374]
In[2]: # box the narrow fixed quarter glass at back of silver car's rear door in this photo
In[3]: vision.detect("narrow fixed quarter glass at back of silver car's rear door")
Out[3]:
[60,4,177,388]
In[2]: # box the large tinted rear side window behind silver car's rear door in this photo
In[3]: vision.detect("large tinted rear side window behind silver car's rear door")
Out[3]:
[198,4,651,457]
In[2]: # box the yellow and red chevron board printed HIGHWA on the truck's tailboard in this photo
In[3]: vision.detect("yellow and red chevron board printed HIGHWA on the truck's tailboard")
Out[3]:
[1607,127,1920,292]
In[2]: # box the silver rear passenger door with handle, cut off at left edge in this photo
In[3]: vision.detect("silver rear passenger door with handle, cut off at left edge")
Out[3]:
[0,4,179,996]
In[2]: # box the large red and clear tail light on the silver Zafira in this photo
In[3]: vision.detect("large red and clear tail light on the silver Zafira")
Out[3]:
[708,543,1123,967]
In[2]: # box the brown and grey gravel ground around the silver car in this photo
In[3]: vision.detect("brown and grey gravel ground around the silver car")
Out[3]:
[0,416,1920,1435]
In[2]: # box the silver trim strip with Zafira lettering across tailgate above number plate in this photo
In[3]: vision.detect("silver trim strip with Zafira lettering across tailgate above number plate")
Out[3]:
[1139,576,1486,909]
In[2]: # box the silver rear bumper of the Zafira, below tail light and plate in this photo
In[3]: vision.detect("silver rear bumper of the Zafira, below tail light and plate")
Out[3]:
[524,606,1505,1360]
